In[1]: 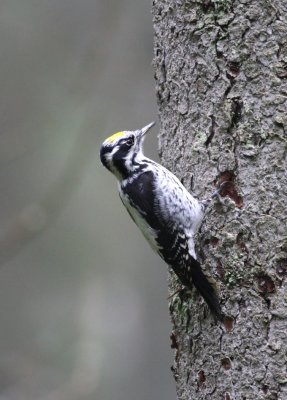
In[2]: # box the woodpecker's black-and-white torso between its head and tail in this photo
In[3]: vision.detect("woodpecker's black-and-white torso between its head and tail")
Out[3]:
[120,160,203,262]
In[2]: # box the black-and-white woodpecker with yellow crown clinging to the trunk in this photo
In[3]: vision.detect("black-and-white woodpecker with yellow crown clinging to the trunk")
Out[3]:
[100,122,223,321]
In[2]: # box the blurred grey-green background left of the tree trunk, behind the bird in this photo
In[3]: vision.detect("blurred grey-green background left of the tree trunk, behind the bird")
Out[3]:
[0,0,176,400]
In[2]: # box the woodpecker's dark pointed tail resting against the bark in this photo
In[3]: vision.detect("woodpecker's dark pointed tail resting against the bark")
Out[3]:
[172,257,224,321]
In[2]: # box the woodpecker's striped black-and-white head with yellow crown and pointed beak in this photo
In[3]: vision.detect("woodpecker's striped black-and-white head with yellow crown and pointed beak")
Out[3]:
[100,122,155,180]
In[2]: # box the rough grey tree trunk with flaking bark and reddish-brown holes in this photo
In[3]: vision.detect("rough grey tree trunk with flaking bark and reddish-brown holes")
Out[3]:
[153,0,287,400]
